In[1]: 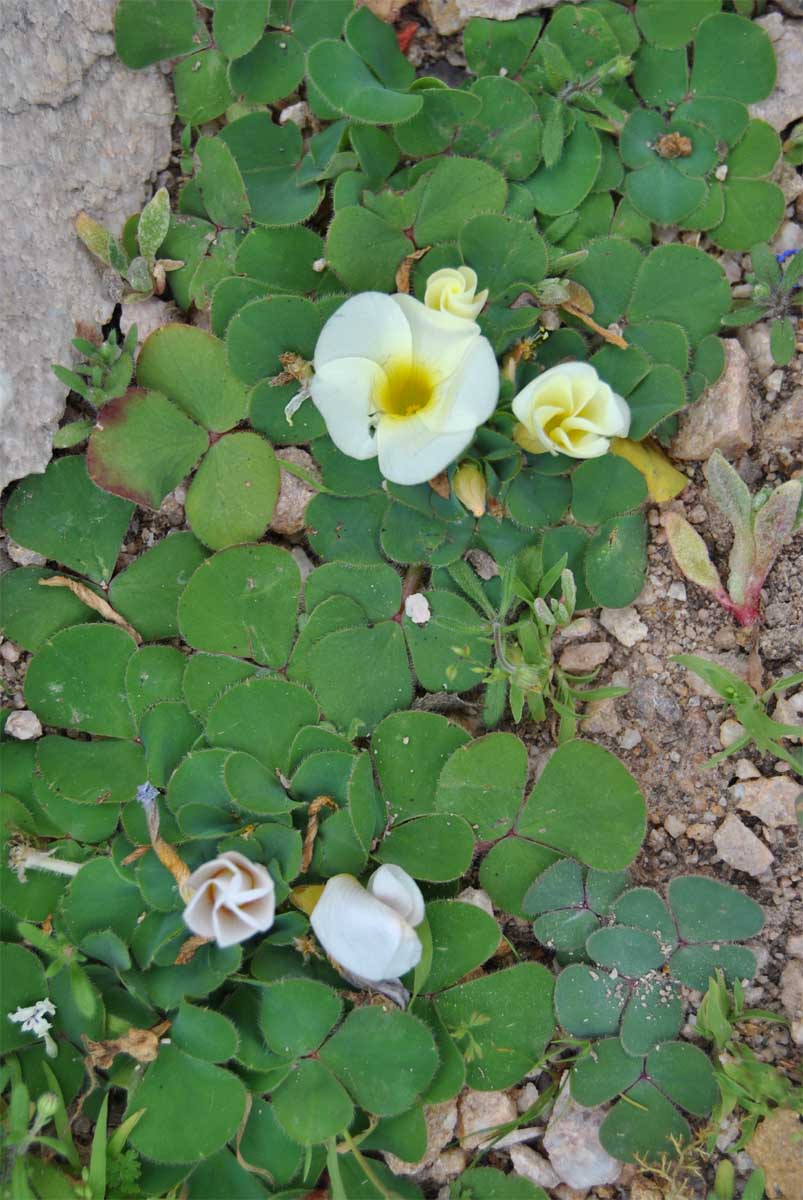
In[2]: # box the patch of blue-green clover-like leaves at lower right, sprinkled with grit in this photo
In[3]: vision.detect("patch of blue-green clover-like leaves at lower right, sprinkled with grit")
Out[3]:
[523,859,763,1160]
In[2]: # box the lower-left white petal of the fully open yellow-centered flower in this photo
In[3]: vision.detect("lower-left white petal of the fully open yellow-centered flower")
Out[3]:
[310,358,385,458]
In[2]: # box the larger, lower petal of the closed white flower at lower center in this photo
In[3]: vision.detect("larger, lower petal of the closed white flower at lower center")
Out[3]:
[310,875,421,983]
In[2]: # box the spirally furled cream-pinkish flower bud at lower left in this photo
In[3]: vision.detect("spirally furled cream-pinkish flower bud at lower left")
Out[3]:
[184,850,276,947]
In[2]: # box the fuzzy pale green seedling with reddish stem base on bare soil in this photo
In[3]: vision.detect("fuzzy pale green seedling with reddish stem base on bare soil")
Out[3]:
[664,450,803,628]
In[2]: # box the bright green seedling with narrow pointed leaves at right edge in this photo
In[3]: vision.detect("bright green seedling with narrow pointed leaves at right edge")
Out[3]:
[670,654,803,775]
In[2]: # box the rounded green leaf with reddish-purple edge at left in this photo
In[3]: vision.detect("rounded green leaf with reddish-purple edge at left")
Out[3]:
[86,388,209,509]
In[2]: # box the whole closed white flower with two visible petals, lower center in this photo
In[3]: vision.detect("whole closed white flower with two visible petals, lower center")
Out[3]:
[310,863,424,983]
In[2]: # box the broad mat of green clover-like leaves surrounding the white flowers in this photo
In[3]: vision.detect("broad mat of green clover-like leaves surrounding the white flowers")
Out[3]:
[0,0,780,1200]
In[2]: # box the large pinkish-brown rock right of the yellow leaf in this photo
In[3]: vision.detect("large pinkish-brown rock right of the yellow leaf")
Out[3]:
[671,337,753,462]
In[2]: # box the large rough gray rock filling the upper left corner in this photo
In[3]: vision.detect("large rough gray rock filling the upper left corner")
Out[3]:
[0,0,173,486]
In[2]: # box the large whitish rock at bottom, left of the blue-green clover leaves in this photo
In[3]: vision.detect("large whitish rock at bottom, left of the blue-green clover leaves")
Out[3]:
[544,1078,622,1188]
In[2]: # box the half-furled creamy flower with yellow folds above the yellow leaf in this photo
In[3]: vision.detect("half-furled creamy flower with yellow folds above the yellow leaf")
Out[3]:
[513,362,630,458]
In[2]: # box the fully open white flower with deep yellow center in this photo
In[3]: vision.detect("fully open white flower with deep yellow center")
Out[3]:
[311,292,499,485]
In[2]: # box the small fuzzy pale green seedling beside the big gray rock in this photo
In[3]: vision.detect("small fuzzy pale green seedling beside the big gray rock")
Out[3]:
[76,187,184,301]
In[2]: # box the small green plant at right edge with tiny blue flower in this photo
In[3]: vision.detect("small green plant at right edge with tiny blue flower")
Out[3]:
[723,245,803,367]
